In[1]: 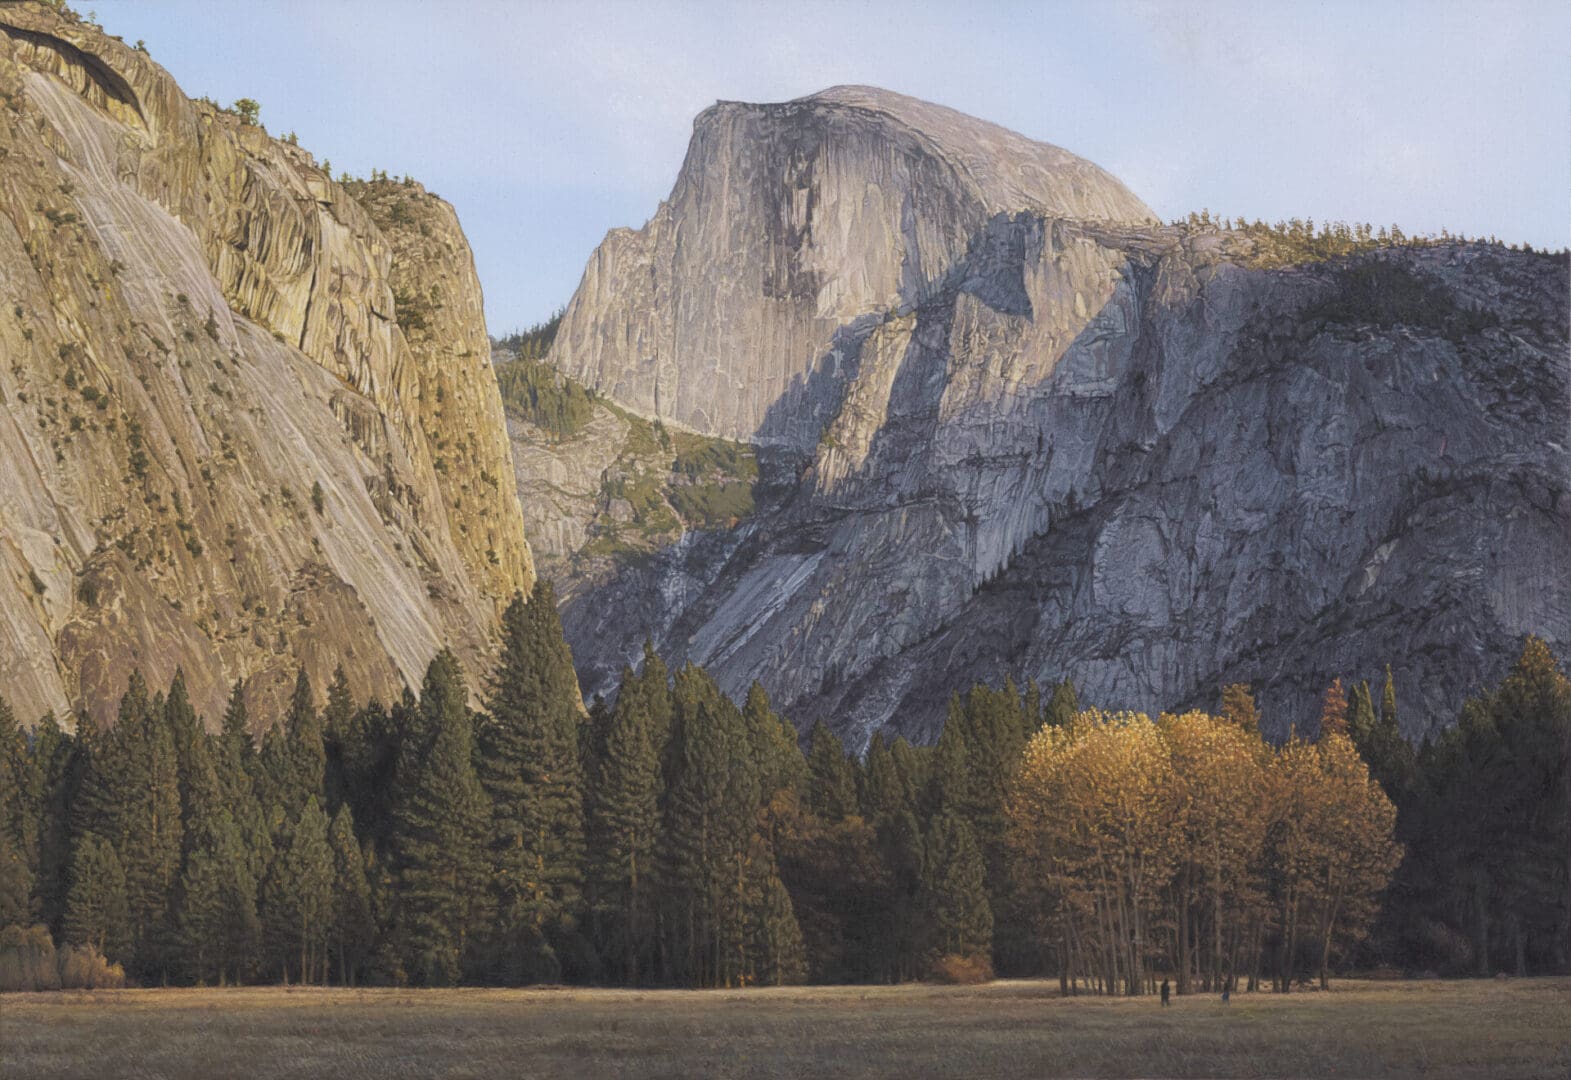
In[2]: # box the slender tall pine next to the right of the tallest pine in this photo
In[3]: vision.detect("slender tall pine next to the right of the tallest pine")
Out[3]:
[586,671,660,984]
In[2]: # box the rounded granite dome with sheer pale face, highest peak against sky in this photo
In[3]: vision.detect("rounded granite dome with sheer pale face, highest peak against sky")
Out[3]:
[551,86,1153,450]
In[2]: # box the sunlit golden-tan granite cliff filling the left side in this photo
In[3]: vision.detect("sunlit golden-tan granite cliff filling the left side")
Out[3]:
[0,3,533,722]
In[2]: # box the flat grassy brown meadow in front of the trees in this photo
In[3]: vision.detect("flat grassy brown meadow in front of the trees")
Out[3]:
[0,979,1571,1080]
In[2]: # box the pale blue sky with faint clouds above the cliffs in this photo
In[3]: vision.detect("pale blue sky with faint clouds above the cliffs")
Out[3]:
[91,0,1571,333]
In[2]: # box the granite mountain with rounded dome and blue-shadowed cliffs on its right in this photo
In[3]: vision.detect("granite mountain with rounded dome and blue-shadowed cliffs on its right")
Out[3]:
[551,90,1571,745]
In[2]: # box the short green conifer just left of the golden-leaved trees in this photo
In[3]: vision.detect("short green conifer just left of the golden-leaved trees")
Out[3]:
[917,811,993,962]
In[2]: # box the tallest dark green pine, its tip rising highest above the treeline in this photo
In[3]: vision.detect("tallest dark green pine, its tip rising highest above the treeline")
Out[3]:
[479,579,583,981]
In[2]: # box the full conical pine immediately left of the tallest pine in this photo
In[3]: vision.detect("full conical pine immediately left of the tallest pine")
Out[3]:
[391,649,489,986]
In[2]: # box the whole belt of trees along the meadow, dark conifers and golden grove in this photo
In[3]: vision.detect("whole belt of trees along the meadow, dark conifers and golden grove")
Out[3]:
[0,582,1571,994]
